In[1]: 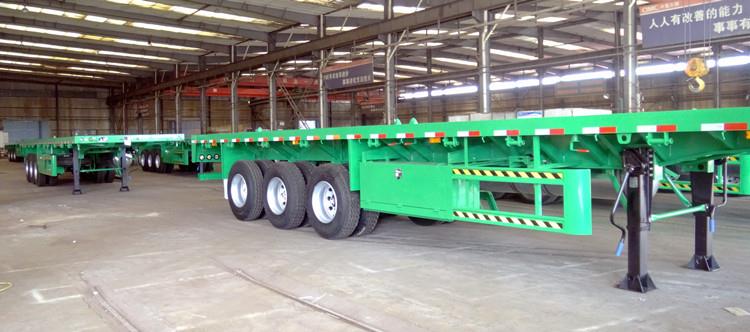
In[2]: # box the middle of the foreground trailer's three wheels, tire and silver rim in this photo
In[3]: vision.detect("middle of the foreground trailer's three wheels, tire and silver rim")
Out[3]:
[263,162,305,229]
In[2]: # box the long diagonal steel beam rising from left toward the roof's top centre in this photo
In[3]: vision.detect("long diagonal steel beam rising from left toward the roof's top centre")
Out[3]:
[116,0,530,99]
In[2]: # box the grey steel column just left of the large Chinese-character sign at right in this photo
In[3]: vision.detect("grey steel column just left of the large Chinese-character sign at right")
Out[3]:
[623,0,641,113]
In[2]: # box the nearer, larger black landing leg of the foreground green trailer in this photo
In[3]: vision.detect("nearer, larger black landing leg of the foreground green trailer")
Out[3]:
[617,148,656,293]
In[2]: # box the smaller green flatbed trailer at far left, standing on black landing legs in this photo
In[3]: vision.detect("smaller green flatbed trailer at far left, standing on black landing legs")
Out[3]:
[17,134,185,194]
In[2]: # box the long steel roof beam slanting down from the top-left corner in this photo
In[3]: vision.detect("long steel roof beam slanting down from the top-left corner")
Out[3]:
[7,0,266,41]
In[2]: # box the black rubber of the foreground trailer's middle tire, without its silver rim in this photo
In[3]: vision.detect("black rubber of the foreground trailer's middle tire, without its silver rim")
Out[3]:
[263,161,305,229]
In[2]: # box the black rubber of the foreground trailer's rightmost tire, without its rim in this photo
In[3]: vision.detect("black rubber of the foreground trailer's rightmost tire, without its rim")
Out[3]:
[306,164,360,240]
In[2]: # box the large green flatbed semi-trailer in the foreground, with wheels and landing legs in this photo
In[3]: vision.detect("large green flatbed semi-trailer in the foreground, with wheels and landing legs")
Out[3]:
[192,108,750,292]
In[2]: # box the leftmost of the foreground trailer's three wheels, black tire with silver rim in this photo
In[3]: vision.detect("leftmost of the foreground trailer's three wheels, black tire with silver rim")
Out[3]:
[227,160,263,221]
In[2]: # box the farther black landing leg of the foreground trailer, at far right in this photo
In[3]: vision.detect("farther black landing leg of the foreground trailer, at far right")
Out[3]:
[688,167,727,271]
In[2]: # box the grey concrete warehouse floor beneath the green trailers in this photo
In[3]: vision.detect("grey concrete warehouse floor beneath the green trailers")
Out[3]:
[0,160,750,331]
